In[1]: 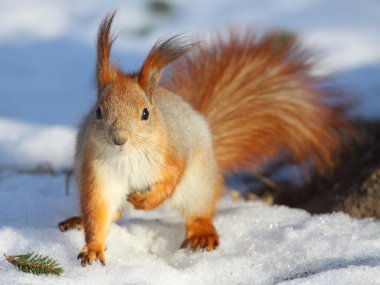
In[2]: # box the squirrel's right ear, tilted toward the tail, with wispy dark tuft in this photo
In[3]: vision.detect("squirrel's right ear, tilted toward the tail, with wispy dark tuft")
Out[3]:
[138,35,194,101]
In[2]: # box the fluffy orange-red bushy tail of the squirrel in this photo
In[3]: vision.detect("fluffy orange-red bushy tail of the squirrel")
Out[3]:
[164,31,353,173]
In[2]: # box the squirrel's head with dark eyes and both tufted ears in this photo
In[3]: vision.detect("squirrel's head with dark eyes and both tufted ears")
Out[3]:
[93,13,192,149]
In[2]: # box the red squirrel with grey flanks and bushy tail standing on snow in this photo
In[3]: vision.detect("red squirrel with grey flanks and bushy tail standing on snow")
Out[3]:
[59,12,351,266]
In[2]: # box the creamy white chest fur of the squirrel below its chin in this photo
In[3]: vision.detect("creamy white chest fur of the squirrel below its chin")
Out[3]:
[96,145,159,213]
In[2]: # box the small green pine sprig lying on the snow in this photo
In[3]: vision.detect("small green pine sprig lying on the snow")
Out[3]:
[4,252,63,275]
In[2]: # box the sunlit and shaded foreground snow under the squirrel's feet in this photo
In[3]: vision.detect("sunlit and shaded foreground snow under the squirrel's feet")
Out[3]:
[0,175,380,284]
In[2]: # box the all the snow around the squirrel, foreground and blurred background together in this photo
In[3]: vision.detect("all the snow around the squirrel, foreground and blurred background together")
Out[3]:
[0,0,380,284]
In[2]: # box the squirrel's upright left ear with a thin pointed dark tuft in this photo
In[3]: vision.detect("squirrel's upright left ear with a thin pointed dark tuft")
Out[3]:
[96,12,116,94]
